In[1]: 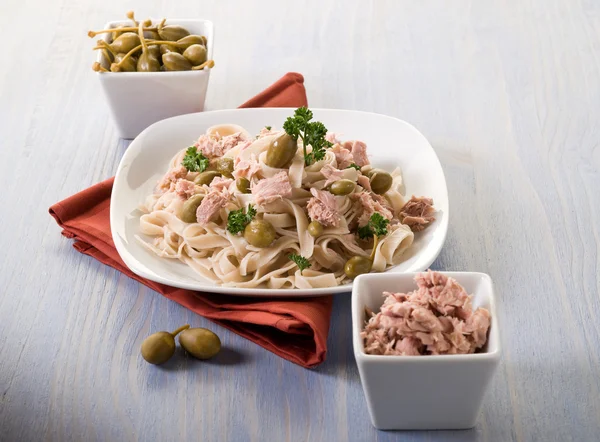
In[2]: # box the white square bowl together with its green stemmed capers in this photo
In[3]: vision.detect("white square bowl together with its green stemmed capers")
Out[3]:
[88,12,215,138]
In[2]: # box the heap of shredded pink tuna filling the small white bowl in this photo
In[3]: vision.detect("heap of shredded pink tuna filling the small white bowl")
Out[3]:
[361,270,490,356]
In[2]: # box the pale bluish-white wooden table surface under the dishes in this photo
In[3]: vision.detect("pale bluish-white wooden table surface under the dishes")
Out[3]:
[0,0,600,442]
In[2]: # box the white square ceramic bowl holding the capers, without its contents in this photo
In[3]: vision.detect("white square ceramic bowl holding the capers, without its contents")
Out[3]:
[96,20,214,138]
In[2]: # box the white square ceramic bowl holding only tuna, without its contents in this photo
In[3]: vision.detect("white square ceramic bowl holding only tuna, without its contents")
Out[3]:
[352,272,500,430]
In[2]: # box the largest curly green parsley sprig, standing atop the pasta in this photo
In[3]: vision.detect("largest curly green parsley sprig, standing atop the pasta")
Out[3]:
[283,107,333,166]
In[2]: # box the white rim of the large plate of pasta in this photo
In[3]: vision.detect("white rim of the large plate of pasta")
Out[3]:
[110,107,450,297]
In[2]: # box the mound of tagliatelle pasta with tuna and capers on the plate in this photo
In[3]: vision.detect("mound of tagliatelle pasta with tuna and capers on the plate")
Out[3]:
[137,111,432,289]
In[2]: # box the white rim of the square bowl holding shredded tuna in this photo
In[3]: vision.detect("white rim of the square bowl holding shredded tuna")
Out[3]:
[352,271,502,364]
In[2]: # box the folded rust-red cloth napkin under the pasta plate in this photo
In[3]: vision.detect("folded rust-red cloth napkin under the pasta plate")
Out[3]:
[50,73,332,367]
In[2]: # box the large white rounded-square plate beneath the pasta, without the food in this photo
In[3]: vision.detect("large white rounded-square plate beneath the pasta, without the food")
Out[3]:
[110,108,448,296]
